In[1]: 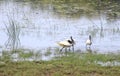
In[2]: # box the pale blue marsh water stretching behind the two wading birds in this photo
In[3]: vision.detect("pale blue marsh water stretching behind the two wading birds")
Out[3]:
[0,0,120,53]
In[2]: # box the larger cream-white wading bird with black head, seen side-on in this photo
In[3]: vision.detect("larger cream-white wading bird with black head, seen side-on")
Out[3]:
[58,36,75,52]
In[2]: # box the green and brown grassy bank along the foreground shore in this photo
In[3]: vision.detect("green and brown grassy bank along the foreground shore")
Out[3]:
[0,51,120,76]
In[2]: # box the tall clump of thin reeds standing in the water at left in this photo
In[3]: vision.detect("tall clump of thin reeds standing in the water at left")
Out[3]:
[5,16,20,50]
